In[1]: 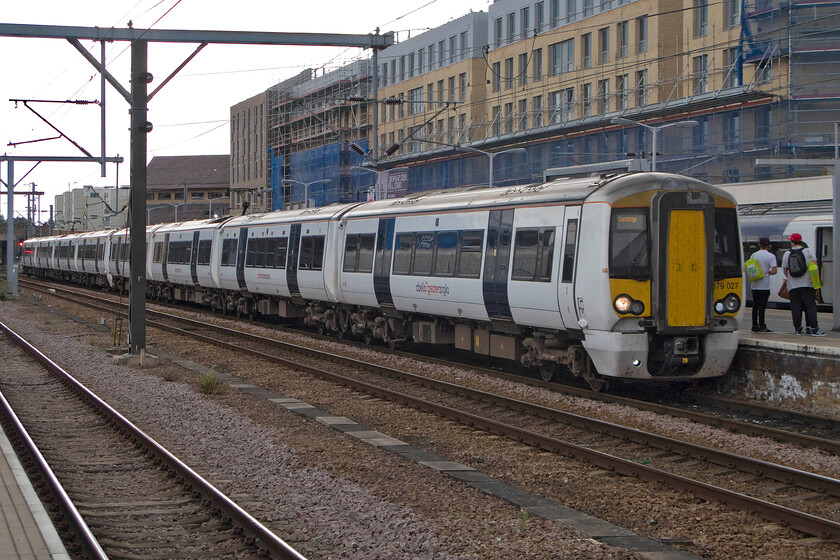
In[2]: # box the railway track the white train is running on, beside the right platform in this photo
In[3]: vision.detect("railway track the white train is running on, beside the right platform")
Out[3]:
[20,279,840,455]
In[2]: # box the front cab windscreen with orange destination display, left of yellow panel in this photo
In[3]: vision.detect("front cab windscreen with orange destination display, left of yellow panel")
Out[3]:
[610,208,650,280]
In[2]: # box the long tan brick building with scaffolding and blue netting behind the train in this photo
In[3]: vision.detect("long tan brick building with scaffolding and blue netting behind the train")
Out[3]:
[231,0,840,208]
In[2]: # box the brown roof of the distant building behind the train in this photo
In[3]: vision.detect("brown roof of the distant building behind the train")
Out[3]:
[146,154,230,191]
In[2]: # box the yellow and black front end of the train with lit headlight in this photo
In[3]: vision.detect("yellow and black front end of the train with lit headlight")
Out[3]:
[584,177,743,380]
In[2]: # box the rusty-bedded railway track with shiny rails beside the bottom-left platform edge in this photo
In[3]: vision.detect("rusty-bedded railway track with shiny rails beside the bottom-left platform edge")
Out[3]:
[0,323,303,559]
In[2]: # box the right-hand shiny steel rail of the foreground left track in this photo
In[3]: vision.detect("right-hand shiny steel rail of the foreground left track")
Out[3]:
[0,322,305,560]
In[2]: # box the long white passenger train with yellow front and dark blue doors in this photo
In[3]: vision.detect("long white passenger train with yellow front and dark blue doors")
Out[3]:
[22,173,744,390]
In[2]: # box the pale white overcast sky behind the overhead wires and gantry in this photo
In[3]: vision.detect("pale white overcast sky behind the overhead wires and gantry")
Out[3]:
[0,0,492,221]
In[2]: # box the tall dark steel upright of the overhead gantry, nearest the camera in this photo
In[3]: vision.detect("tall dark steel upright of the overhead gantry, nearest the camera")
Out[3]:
[129,40,149,355]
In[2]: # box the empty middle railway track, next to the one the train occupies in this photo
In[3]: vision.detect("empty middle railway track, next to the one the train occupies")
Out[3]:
[16,280,840,542]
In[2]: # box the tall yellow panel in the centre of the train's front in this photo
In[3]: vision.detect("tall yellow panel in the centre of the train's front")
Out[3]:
[667,210,706,327]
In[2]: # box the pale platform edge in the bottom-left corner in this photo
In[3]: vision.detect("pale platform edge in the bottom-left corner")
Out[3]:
[0,422,70,560]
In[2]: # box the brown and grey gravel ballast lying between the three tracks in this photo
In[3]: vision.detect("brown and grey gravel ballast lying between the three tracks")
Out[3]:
[0,298,840,560]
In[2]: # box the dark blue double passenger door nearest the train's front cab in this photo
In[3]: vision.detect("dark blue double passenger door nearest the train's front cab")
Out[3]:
[482,209,513,319]
